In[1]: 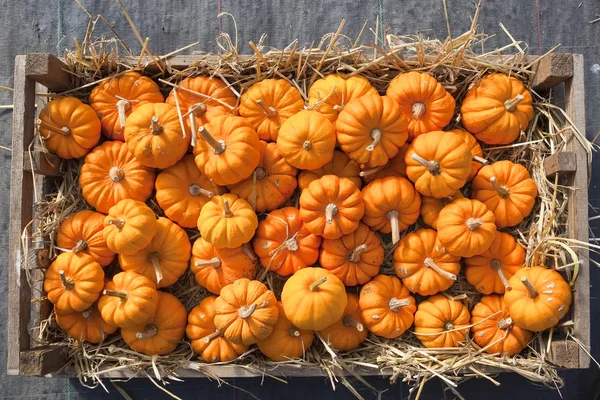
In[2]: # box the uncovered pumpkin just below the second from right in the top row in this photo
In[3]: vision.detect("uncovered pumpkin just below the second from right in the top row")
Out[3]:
[404,131,472,197]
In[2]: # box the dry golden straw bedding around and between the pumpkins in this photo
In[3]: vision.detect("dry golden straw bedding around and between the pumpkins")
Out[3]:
[23,2,593,398]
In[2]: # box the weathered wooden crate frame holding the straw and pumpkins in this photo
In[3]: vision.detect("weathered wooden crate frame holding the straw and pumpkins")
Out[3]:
[7,54,590,378]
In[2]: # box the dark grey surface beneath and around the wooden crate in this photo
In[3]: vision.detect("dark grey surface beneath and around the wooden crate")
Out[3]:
[0,0,600,400]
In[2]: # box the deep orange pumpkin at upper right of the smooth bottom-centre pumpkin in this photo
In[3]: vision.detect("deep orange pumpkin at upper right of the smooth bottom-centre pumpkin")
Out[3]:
[319,223,384,286]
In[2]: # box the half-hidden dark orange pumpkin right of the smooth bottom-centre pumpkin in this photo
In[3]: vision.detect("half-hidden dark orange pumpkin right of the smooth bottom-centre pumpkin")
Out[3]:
[319,293,369,351]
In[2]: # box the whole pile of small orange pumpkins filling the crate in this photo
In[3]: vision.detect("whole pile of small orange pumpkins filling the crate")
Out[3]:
[37,71,572,362]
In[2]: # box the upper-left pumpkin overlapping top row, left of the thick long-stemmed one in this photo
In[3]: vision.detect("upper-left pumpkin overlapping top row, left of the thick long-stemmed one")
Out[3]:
[125,103,191,169]
